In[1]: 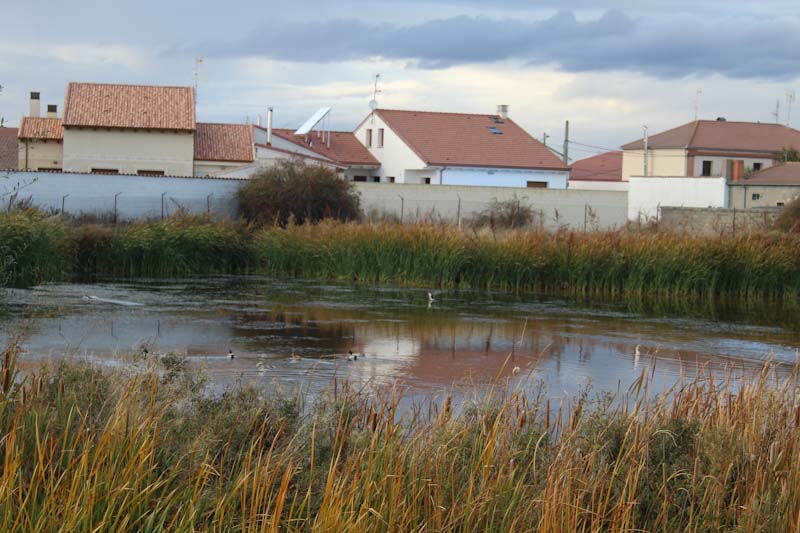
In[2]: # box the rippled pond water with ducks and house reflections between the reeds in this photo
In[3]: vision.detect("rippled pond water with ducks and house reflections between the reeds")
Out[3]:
[0,277,800,397]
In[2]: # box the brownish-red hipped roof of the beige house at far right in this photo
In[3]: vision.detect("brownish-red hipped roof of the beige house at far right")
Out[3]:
[622,120,800,153]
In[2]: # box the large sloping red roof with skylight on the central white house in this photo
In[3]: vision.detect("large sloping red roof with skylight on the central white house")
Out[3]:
[375,109,568,170]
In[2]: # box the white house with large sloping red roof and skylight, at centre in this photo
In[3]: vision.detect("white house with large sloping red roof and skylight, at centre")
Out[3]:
[353,106,569,189]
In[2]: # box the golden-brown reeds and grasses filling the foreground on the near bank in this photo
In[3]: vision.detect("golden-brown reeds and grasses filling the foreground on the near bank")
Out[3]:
[0,338,800,532]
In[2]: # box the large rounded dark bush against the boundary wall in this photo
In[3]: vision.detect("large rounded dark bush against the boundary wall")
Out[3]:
[237,161,361,227]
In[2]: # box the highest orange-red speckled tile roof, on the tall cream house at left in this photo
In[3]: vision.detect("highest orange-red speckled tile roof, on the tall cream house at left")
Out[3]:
[64,82,195,131]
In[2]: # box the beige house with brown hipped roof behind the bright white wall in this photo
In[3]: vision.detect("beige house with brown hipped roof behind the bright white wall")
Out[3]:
[622,119,800,181]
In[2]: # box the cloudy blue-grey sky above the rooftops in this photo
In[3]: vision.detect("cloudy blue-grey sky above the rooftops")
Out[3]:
[0,0,800,158]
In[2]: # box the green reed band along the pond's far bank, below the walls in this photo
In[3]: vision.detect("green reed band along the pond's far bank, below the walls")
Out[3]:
[0,212,800,303]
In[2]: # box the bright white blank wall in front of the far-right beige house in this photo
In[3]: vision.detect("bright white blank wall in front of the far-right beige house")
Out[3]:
[628,176,728,222]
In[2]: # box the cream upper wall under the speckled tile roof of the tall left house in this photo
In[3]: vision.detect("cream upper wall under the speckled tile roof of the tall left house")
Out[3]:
[64,128,194,176]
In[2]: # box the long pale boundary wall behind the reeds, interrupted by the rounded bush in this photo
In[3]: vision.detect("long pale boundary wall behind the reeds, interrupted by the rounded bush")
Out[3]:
[0,171,627,229]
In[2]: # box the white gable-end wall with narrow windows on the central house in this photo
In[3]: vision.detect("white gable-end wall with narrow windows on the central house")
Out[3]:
[355,114,434,183]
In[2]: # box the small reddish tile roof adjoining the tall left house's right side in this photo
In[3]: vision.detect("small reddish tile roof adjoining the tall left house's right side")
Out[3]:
[194,122,254,163]
